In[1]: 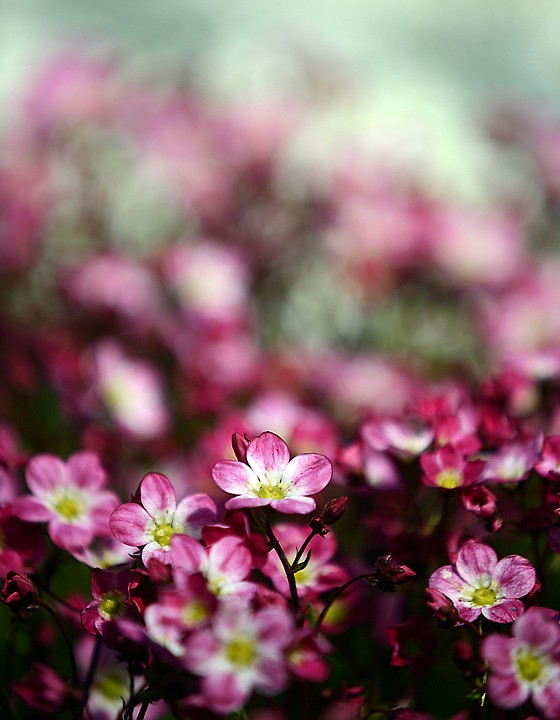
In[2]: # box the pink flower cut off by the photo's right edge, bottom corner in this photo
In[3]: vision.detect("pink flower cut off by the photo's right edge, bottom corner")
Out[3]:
[482,607,560,720]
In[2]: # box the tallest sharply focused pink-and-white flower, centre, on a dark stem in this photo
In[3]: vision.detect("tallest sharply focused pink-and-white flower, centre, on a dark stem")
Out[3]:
[212,432,333,515]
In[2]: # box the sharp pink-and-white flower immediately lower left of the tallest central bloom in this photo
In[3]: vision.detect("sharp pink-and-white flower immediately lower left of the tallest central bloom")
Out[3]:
[109,473,216,565]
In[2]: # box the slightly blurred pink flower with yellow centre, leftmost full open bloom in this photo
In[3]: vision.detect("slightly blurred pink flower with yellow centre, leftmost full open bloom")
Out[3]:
[14,452,118,551]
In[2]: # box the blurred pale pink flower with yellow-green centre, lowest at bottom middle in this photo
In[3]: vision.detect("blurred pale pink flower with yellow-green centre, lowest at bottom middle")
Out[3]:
[185,602,294,714]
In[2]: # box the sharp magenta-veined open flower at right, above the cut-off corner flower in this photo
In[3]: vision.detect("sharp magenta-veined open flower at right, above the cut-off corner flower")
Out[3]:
[429,540,535,623]
